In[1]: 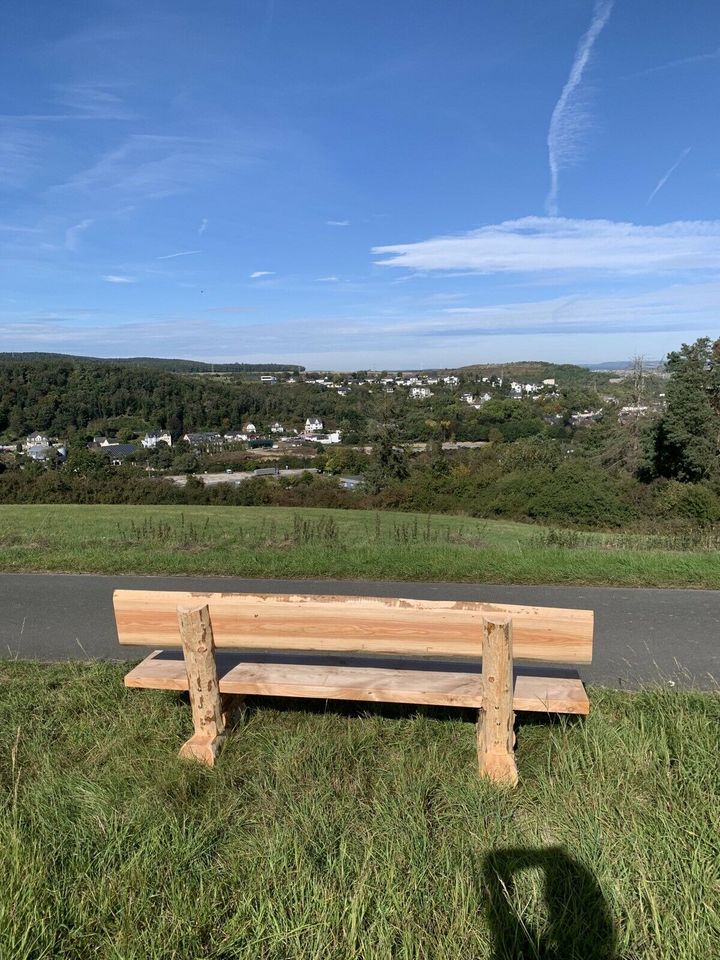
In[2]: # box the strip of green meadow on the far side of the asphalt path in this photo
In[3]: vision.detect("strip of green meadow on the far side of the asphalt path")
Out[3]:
[0,505,720,589]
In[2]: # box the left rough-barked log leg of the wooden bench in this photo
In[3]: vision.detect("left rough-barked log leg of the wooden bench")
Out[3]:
[177,605,225,767]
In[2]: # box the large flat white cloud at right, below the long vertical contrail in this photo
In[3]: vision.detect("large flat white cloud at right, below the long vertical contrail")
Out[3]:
[372,217,720,274]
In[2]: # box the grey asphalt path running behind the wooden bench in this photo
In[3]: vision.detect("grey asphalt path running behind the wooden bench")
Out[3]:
[0,573,720,689]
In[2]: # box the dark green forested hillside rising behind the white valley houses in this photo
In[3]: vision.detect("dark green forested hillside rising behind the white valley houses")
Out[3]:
[0,356,597,443]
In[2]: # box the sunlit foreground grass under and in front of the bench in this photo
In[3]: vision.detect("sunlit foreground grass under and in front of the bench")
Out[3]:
[0,662,720,960]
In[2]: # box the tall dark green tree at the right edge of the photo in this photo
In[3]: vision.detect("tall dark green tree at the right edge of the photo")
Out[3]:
[653,337,720,482]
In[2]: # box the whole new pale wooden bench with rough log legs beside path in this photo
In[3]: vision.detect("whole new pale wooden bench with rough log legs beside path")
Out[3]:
[113,590,593,784]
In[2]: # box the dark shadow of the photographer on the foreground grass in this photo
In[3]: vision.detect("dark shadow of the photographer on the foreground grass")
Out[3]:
[483,847,617,960]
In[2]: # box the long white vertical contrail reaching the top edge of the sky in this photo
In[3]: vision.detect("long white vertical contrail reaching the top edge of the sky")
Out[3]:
[545,0,614,217]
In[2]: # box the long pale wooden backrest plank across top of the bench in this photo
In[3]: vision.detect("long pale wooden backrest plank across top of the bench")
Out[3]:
[113,590,593,664]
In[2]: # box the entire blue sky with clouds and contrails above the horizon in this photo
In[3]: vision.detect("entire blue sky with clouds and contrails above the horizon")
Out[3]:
[0,0,720,369]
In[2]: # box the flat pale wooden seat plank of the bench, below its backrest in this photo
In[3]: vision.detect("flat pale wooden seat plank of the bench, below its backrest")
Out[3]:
[125,650,590,716]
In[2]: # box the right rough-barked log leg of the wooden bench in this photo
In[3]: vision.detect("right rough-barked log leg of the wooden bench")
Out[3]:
[477,617,518,786]
